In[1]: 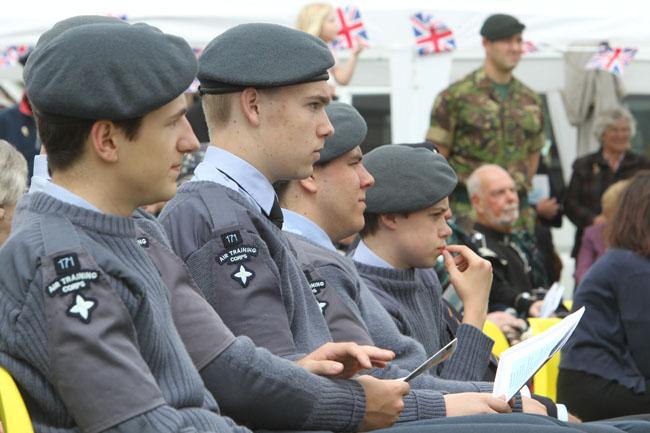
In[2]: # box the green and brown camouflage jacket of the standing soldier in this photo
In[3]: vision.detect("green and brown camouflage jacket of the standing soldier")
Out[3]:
[427,68,545,190]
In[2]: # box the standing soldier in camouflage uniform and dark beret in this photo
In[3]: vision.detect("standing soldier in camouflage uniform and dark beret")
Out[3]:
[427,14,545,232]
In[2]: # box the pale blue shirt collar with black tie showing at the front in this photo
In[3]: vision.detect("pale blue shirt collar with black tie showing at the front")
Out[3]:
[192,145,275,215]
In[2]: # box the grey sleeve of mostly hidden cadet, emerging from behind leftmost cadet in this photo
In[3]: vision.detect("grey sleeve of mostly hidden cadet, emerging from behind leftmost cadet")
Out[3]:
[134,210,365,432]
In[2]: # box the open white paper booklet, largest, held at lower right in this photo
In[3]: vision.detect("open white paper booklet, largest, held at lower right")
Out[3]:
[492,307,585,401]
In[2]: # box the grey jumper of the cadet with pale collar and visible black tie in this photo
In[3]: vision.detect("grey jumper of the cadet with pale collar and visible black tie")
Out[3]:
[159,181,454,422]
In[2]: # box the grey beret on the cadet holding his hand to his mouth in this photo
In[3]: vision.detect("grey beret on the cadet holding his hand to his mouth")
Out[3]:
[363,144,458,214]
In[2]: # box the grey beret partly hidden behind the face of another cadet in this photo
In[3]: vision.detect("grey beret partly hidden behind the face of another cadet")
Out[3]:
[316,102,368,164]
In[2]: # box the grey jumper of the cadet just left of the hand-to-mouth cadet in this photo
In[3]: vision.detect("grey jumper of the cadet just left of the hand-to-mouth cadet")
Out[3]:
[287,233,508,404]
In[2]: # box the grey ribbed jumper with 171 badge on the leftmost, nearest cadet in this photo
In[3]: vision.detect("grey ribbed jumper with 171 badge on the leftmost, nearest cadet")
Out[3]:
[0,193,248,433]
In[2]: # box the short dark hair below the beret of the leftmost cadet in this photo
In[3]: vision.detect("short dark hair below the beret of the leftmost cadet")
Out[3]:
[34,110,144,170]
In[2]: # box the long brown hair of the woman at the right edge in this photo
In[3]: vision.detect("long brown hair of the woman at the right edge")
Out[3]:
[608,170,650,259]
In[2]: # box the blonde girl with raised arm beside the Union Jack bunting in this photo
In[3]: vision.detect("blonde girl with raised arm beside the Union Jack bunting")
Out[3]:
[296,3,364,96]
